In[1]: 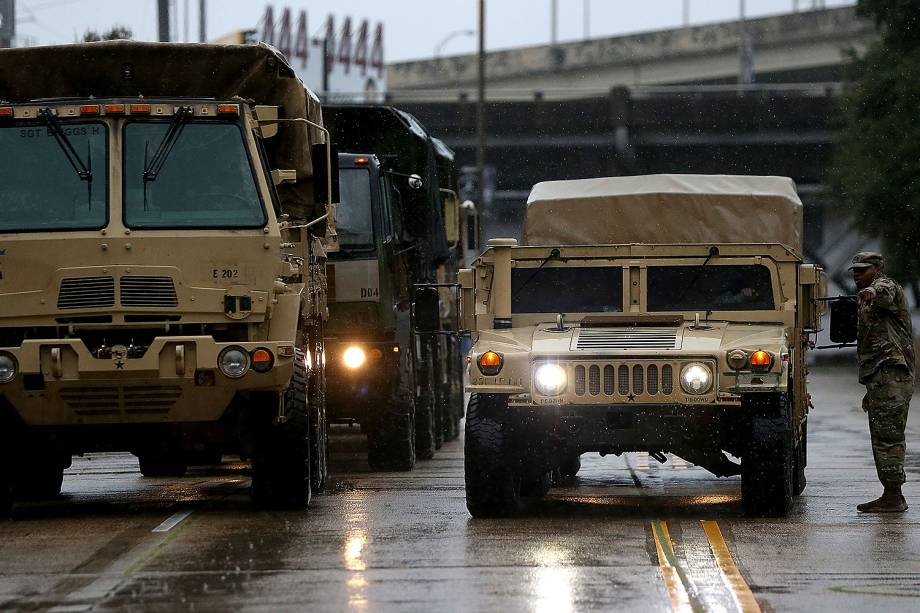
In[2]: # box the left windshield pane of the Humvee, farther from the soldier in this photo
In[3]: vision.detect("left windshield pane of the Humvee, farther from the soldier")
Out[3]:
[511,266,623,313]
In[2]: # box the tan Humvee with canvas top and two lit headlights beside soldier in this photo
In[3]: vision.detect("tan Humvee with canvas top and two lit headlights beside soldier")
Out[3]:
[461,175,826,517]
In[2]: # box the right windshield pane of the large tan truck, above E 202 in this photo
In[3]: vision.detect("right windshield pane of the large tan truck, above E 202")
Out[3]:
[124,121,266,228]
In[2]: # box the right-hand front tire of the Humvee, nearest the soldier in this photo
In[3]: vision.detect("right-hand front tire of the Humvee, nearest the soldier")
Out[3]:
[741,393,794,517]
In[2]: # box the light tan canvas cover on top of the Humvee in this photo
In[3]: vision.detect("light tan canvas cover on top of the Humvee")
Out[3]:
[524,175,803,255]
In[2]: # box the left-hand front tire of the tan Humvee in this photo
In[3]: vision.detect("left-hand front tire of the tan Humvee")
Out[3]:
[463,394,521,517]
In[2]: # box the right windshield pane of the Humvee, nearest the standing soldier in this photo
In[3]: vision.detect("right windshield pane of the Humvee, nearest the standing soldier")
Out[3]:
[648,264,774,311]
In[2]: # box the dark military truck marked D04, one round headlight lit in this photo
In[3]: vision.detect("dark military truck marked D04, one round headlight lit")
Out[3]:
[324,105,463,470]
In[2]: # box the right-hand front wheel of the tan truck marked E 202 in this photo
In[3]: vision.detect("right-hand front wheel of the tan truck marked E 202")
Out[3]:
[252,349,312,509]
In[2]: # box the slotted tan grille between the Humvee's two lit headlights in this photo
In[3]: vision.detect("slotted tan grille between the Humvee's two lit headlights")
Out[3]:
[573,361,675,402]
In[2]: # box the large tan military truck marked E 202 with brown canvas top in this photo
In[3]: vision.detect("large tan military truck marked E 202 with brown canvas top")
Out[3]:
[0,42,335,507]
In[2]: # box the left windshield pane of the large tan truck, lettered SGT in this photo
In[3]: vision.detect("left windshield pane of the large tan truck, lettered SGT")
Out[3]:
[0,122,108,232]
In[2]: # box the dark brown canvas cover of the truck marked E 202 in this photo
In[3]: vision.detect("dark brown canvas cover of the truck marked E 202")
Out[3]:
[0,41,325,226]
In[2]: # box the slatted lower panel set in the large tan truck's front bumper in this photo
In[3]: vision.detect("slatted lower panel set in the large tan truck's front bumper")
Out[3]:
[60,385,182,417]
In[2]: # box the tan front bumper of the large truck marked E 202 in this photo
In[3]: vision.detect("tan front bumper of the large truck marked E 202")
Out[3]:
[0,336,295,426]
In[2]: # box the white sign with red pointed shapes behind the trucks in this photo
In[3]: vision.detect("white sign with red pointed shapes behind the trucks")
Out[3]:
[256,5,386,102]
